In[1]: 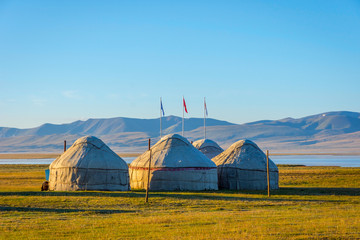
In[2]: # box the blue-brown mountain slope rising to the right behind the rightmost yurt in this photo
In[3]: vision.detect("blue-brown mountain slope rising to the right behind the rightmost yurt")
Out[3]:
[188,111,360,152]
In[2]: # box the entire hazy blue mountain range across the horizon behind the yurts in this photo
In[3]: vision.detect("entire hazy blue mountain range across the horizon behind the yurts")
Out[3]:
[0,111,360,153]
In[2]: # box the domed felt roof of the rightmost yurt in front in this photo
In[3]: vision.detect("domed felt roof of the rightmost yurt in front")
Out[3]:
[212,140,278,171]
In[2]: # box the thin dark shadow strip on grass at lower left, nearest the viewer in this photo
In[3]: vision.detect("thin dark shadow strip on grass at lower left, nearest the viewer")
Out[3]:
[0,206,135,214]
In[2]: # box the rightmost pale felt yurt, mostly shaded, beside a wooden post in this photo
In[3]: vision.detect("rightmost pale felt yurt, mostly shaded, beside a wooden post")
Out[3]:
[212,140,279,190]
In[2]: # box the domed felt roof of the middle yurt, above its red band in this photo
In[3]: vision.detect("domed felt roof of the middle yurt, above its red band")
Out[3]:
[130,134,216,168]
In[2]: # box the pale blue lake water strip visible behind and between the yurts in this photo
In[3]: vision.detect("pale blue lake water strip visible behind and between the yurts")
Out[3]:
[0,155,360,167]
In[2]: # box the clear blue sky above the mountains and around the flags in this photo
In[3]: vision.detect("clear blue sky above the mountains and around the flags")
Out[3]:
[0,0,360,128]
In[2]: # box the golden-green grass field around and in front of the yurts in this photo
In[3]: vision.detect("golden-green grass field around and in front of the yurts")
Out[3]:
[0,165,360,239]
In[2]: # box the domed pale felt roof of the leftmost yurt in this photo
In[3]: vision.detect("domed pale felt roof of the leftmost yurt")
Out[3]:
[49,136,128,170]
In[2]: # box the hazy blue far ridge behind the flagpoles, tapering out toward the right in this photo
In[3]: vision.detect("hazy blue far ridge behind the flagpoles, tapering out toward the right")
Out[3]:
[0,116,234,138]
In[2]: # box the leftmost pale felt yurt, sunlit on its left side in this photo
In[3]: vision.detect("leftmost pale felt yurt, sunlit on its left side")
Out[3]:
[49,136,130,191]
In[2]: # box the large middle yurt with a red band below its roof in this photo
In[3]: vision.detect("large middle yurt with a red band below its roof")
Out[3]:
[129,134,218,191]
